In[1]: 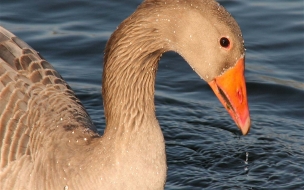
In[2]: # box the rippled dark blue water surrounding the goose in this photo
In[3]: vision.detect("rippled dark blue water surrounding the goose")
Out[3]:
[0,0,304,190]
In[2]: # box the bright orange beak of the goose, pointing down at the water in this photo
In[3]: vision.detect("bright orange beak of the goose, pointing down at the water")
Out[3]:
[208,57,250,135]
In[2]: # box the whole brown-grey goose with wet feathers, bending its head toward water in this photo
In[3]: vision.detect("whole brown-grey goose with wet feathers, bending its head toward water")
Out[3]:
[0,0,250,190]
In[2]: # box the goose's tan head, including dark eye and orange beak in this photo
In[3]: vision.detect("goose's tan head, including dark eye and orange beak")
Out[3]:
[144,0,250,135]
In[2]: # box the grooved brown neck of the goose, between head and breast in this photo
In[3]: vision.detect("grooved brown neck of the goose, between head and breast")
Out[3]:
[102,16,167,133]
